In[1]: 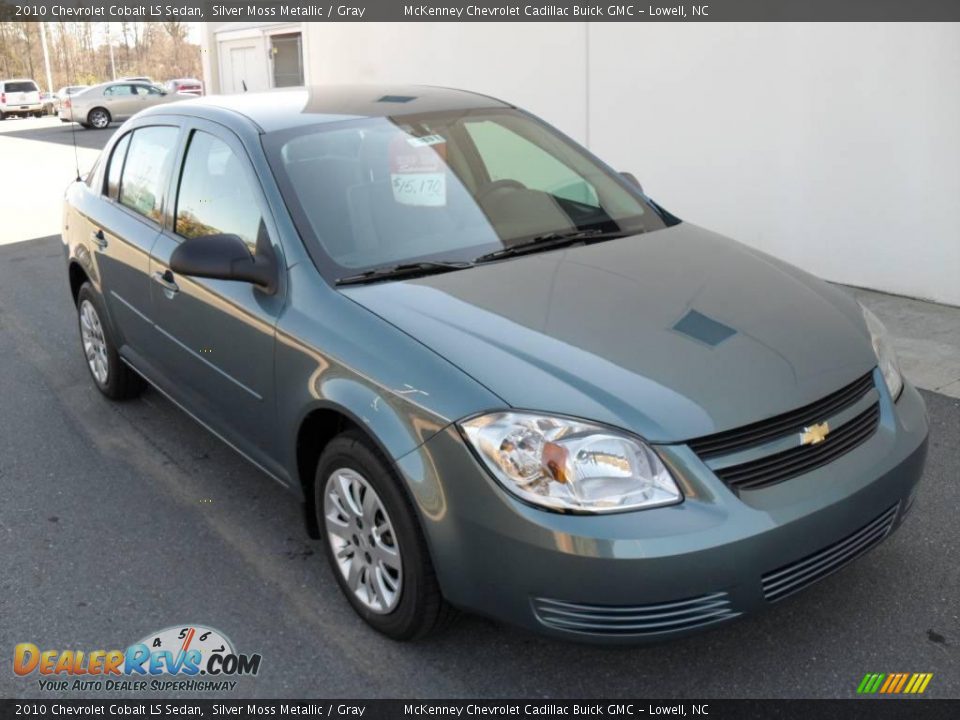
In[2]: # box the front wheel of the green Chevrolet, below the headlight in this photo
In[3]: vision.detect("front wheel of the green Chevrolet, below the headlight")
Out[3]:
[314,432,454,640]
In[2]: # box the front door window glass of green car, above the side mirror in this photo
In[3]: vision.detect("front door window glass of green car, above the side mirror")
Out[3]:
[174,130,261,252]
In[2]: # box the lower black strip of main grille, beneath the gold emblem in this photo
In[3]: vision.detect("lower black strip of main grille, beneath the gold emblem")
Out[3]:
[714,403,880,491]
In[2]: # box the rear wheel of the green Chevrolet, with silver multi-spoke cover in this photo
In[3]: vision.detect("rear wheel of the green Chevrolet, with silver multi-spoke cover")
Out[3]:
[77,282,146,400]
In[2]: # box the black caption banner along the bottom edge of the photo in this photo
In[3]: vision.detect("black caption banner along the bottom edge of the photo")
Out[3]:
[0,698,960,720]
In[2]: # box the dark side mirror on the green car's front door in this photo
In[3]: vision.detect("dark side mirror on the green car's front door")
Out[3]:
[170,234,277,294]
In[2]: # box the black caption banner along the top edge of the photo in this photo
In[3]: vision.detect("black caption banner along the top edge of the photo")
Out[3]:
[0,0,960,23]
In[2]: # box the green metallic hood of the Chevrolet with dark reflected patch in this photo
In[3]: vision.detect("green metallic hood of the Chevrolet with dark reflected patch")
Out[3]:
[343,223,876,442]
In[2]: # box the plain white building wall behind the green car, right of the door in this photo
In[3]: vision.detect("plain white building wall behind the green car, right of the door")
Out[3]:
[262,23,960,305]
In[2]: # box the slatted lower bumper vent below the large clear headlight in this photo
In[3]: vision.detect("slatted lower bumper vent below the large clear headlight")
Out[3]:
[533,592,740,635]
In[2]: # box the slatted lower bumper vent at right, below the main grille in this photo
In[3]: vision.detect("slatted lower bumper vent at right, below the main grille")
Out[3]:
[761,503,900,602]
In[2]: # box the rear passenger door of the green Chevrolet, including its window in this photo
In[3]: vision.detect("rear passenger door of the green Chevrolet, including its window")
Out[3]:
[78,124,180,358]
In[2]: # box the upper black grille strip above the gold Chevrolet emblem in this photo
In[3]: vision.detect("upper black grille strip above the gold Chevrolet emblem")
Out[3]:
[687,371,873,460]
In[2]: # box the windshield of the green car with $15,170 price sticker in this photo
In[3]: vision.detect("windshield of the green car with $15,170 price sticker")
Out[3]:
[264,108,666,278]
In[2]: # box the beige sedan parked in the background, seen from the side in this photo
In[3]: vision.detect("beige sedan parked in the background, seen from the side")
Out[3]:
[59,80,196,130]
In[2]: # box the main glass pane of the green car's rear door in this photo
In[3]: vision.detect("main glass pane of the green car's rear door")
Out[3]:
[119,126,179,223]
